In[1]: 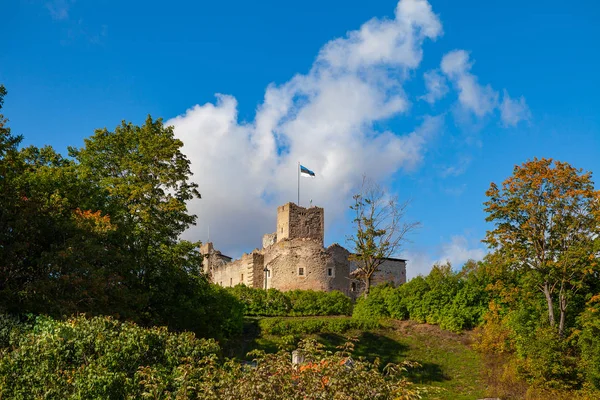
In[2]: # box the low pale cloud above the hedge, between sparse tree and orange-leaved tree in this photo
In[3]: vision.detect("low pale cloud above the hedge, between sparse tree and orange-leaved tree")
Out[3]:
[406,235,486,279]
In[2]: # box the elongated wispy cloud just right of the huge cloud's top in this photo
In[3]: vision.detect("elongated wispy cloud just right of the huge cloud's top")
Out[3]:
[441,50,498,117]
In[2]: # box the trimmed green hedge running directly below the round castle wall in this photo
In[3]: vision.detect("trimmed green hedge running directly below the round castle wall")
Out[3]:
[226,284,352,317]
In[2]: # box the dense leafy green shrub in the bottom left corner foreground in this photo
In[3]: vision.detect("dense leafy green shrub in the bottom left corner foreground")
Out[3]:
[0,317,220,399]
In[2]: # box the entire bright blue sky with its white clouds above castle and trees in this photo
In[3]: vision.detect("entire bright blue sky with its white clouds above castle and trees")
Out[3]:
[0,0,600,276]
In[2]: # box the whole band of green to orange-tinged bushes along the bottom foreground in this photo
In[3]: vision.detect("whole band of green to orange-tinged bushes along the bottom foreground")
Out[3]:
[0,317,418,399]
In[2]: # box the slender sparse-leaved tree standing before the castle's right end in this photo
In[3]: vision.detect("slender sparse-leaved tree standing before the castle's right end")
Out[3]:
[348,177,420,297]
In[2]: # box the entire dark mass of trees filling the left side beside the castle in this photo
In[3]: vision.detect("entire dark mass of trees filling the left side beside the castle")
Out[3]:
[0,86,243,338]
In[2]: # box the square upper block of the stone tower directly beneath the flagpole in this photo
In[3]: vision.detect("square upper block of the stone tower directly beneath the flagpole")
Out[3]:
[275,203,325,246]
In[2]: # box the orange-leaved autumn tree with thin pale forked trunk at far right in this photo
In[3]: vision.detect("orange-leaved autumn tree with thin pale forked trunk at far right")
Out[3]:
[484,158,600,337]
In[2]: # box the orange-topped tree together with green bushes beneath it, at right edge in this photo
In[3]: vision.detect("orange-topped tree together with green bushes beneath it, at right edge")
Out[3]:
[478,159,600,390]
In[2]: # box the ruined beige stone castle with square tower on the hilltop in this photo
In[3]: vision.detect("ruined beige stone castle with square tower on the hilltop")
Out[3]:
[200,203,406,297]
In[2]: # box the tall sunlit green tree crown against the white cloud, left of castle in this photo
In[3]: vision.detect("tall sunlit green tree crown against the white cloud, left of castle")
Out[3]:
[69,116,200,287]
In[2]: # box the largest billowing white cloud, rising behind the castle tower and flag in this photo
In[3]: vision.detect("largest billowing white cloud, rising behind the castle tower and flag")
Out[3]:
[167,0,444,256]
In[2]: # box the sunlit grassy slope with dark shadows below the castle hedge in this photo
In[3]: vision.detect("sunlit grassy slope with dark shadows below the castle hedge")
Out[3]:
[229,317,486,399]
